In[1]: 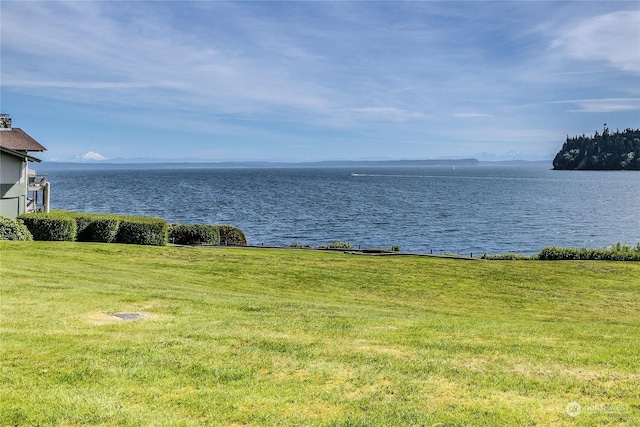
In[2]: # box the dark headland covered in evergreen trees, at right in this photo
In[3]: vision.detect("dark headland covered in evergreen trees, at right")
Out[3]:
[553,125,640,170]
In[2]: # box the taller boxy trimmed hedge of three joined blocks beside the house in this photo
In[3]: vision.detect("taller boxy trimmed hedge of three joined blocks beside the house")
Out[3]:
[19,211,168,246]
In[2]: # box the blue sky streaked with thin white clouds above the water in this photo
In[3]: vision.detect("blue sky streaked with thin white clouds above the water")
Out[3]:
[0,0,640,161]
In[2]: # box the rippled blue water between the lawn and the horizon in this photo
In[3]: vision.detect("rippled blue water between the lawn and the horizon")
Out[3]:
[47,166,640,254]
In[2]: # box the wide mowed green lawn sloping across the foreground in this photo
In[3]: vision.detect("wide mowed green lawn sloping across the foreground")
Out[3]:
[0,242,640,426]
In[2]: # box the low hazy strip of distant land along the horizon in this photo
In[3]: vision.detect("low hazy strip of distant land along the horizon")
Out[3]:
[35,158,551,171]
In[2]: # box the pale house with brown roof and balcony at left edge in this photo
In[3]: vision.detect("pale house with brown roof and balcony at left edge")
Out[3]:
[0,114,50,219]
